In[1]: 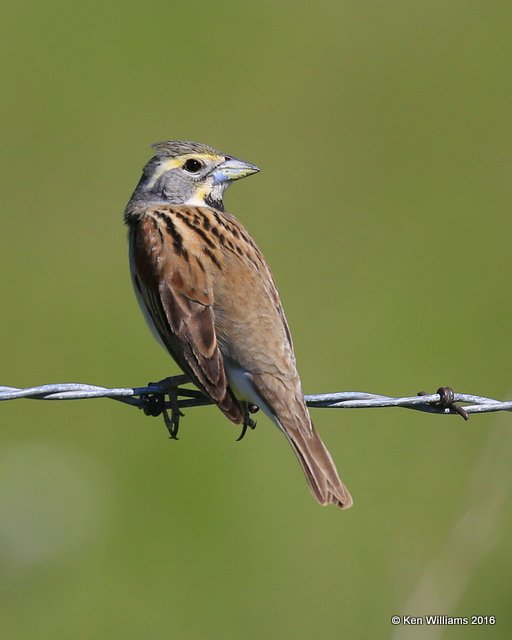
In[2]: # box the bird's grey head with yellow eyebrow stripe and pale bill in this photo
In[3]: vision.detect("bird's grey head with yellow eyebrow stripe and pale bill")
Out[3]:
[134,140,259,210]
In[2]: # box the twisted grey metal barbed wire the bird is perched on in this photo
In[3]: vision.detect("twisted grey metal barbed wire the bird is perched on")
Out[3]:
[0,375,512,420]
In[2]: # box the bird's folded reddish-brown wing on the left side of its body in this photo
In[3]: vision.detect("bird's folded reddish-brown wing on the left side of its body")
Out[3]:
[130,210,243,424]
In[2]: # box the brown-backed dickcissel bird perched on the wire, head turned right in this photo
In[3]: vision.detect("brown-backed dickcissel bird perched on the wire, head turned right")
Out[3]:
[124,141,352,508]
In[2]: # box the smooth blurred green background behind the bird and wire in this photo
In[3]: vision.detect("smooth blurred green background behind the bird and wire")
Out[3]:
[0,0,512,640]
